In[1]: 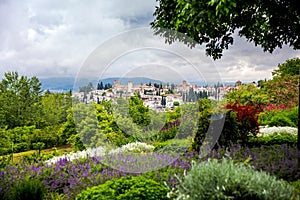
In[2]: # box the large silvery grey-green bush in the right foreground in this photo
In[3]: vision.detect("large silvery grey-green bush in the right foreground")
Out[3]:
[169,159,297,200]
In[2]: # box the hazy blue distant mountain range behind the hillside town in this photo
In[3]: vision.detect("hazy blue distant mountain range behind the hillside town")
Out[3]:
[40,77,234,91]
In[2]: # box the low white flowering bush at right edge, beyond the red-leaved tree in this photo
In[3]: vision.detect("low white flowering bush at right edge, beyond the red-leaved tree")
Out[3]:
[257,126,298,136]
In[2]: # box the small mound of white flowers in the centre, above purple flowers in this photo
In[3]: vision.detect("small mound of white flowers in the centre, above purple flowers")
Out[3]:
[109,142,155,154]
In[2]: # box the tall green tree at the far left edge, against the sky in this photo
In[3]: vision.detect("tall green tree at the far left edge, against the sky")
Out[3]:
[0,72,41,128]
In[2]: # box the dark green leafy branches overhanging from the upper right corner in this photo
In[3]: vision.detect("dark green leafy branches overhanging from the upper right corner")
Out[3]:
[151,0,300,59]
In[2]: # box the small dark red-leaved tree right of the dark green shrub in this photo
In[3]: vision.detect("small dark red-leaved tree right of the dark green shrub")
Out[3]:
[226,101,261,143]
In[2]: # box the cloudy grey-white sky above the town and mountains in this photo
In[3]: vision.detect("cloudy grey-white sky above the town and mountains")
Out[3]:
[0,0,300,81]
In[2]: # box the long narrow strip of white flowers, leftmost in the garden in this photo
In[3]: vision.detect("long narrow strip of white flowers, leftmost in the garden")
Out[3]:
[45,147,106,164]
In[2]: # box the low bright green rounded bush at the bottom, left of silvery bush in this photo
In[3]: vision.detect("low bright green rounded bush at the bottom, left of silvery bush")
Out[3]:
[76,176,168,200]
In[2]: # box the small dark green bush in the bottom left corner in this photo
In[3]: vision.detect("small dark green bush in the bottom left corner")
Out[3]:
[7,177,46,200]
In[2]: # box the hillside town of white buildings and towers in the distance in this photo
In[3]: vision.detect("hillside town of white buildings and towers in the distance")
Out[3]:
[73,80,248,111]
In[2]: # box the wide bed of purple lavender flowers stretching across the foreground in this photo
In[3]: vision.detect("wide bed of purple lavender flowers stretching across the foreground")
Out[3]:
[0,145,300,199]
